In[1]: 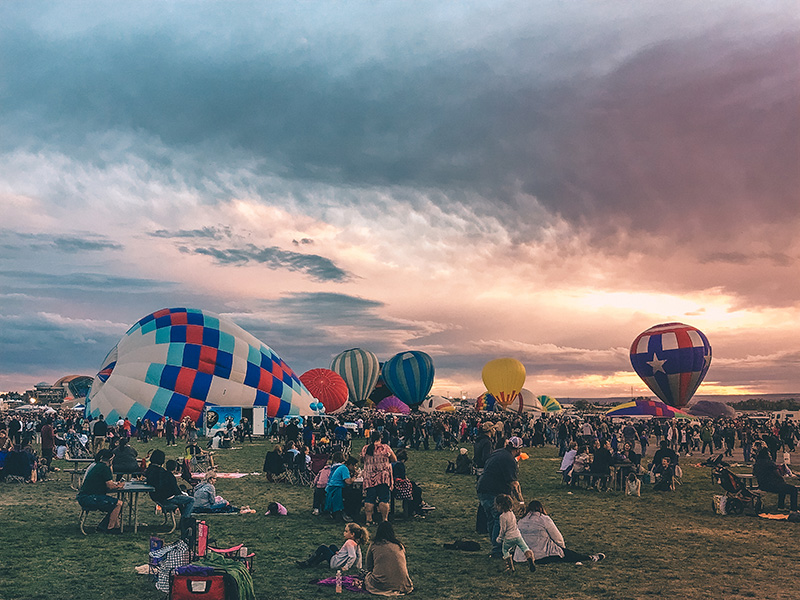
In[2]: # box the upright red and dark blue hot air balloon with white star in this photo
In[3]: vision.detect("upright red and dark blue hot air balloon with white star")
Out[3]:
[631,323,711,408]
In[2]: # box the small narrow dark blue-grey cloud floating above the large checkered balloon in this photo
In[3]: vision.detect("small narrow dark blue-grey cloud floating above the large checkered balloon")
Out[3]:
[188,244,350,282]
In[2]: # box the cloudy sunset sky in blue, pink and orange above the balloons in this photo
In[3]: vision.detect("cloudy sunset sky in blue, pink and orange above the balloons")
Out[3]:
[0,0,800,397]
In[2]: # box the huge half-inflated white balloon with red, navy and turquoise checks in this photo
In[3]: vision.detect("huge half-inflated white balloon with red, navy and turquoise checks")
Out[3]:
[87,308,316,422]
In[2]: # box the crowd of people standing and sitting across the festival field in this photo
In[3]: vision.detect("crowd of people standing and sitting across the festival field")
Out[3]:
[0,400,800,594]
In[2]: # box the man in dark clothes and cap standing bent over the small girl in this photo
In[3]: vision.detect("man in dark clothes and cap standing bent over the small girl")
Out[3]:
[476,436,525,558]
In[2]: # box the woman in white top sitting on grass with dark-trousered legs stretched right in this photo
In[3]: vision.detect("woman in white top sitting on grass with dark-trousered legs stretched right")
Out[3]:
[514,500,606,565]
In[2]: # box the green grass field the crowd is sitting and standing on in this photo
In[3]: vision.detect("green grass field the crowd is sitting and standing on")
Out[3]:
[0,440,800,600]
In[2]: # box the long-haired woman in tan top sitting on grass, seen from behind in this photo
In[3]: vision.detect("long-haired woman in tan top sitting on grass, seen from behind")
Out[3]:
[364,521,414,596]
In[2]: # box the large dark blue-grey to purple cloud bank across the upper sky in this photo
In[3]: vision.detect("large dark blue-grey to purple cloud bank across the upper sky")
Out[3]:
[0,3,800,246]
